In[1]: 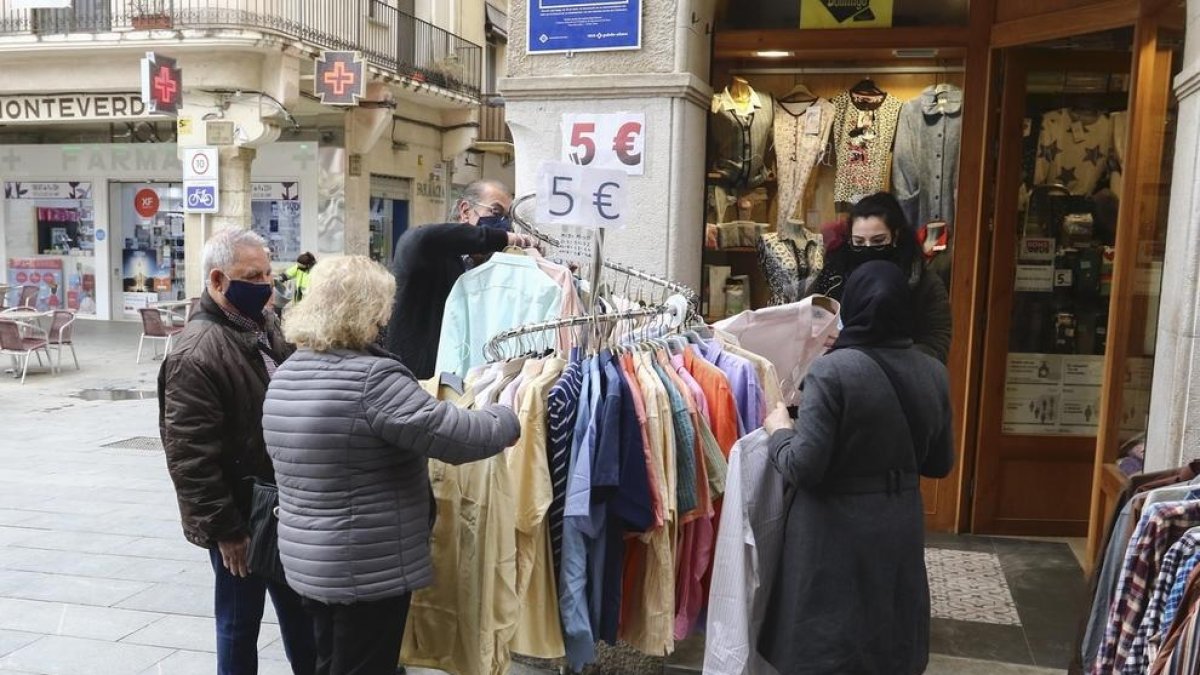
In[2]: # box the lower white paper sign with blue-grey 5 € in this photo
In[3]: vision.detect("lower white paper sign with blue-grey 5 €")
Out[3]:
[538,162,629,229]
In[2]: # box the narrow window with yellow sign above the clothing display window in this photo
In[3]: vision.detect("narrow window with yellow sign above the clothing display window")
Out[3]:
[716,0,971,30]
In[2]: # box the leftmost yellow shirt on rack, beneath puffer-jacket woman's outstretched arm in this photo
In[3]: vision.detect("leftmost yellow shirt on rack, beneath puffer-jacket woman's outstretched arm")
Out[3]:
[401,380,520,675]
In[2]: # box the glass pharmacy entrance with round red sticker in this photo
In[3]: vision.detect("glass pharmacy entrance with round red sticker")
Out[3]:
[108,183,187,321]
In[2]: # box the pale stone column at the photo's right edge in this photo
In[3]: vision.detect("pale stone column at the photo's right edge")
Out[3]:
[1146,0,1200,471]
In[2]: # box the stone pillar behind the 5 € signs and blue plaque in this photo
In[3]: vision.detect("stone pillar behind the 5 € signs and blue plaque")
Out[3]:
[500,0,713,291]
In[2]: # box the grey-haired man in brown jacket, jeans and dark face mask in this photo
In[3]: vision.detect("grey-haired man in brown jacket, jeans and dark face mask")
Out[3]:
[158,229,316,675]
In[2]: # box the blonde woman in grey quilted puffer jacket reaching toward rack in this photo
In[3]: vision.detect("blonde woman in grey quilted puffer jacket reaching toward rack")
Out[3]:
[263,256,521,675]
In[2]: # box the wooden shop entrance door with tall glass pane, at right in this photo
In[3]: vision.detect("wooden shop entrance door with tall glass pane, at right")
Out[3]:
[972,13,1182,537]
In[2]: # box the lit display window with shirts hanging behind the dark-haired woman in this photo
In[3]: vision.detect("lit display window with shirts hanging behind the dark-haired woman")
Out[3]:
[702,61,970,319]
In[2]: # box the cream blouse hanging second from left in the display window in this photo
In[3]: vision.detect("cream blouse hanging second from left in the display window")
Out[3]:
[775,98,836,232]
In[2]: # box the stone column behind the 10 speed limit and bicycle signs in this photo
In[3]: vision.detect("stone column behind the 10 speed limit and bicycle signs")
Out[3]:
[184,147,257,298]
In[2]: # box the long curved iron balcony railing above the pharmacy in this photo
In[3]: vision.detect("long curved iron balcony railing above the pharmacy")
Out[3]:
[0,0,482,97]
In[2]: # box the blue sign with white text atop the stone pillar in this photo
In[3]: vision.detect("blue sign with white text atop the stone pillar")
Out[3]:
[527,0,642,54]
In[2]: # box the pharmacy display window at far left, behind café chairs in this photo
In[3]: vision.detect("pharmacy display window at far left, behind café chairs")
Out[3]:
[5,181,96,316]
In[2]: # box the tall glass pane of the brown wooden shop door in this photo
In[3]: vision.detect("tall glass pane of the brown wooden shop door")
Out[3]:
[1003,60,1128,436]
